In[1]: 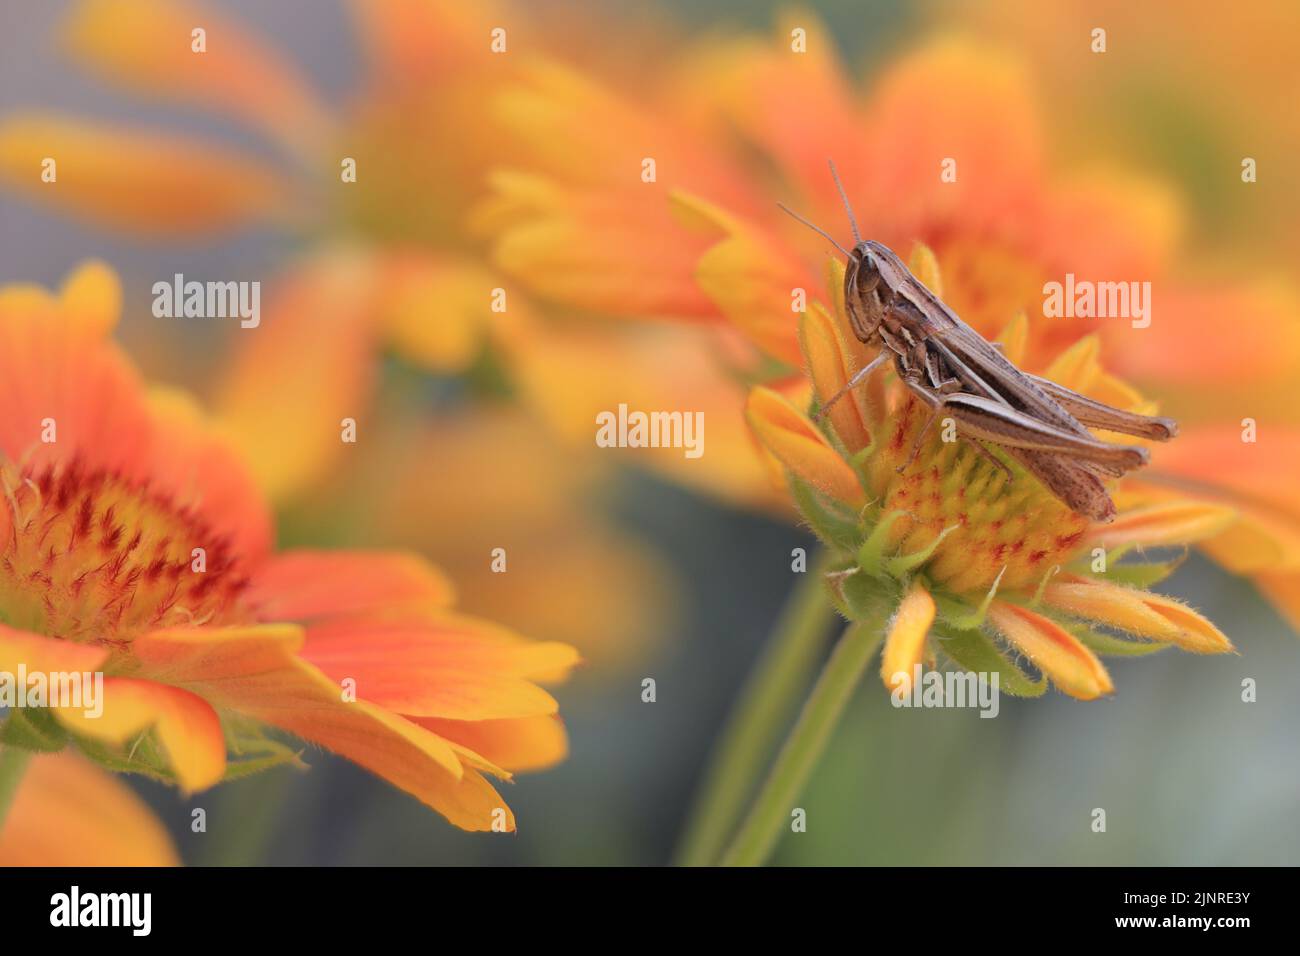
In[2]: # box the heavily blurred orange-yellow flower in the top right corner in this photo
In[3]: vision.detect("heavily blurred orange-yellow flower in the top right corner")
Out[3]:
[928,0,1300,265]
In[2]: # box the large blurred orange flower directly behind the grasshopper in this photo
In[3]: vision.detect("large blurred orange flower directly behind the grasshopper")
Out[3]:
[481,18,1300,627]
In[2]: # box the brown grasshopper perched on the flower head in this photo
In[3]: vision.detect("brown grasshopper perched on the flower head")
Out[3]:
[781,163,1178,522]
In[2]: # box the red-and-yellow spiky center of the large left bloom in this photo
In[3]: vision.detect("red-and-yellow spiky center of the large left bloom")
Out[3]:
[0,460,247,646]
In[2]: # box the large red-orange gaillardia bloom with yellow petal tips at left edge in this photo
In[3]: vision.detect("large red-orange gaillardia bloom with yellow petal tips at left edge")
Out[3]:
[0,264,576,830]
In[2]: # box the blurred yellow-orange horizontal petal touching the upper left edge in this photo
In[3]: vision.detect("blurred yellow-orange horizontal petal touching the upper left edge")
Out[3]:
[0,114,290,235]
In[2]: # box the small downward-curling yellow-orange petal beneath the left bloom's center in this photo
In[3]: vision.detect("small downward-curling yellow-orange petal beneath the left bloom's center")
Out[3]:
[55,678,226,792]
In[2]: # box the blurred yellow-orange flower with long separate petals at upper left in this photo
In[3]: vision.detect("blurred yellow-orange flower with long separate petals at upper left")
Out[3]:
[0,0,543,501]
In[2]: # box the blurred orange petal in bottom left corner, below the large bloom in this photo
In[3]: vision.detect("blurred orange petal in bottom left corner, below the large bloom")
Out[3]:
[0,750,181,866]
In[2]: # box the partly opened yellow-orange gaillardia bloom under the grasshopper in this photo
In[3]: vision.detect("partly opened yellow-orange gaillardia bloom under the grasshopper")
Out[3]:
[748,252,1232,700]
